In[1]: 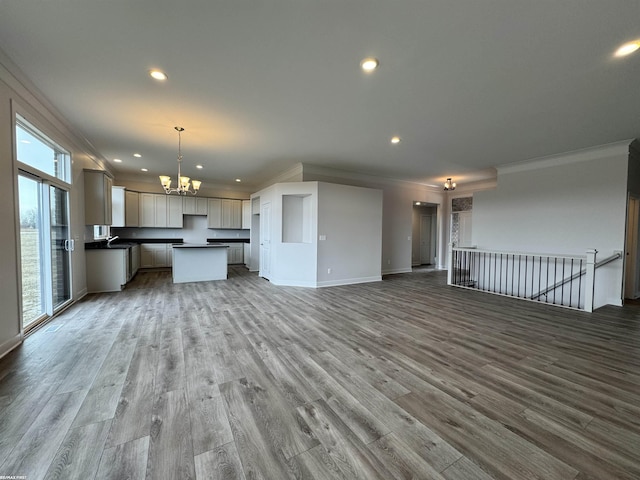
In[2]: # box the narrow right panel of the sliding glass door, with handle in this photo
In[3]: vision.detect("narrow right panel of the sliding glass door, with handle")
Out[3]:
[49,185,72,311]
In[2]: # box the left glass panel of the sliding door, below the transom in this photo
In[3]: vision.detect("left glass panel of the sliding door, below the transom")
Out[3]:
[18,175,47,327]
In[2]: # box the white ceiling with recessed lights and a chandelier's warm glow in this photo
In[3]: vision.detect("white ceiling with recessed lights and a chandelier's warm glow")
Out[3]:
[0,0,640,189]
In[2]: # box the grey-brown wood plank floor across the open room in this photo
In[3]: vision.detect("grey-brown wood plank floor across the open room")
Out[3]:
[0,268,640,480]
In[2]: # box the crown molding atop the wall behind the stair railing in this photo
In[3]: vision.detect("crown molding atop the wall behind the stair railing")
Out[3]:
[497,139,633,175]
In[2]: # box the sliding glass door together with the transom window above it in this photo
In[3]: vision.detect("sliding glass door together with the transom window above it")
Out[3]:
[16,118,73,330]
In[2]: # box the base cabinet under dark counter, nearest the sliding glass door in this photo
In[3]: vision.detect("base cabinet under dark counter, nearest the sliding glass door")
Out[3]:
[85,248,129,293]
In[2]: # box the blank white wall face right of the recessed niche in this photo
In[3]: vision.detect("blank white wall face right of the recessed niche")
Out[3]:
[317,182,382,286]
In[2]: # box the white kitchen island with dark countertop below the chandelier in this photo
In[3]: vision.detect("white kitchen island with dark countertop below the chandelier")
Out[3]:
[172,243,228,283]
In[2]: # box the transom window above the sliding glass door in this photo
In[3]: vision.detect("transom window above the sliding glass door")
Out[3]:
[16,116,71,183]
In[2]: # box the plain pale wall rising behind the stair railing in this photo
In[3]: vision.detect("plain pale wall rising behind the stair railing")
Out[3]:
[473,142,628,308]
